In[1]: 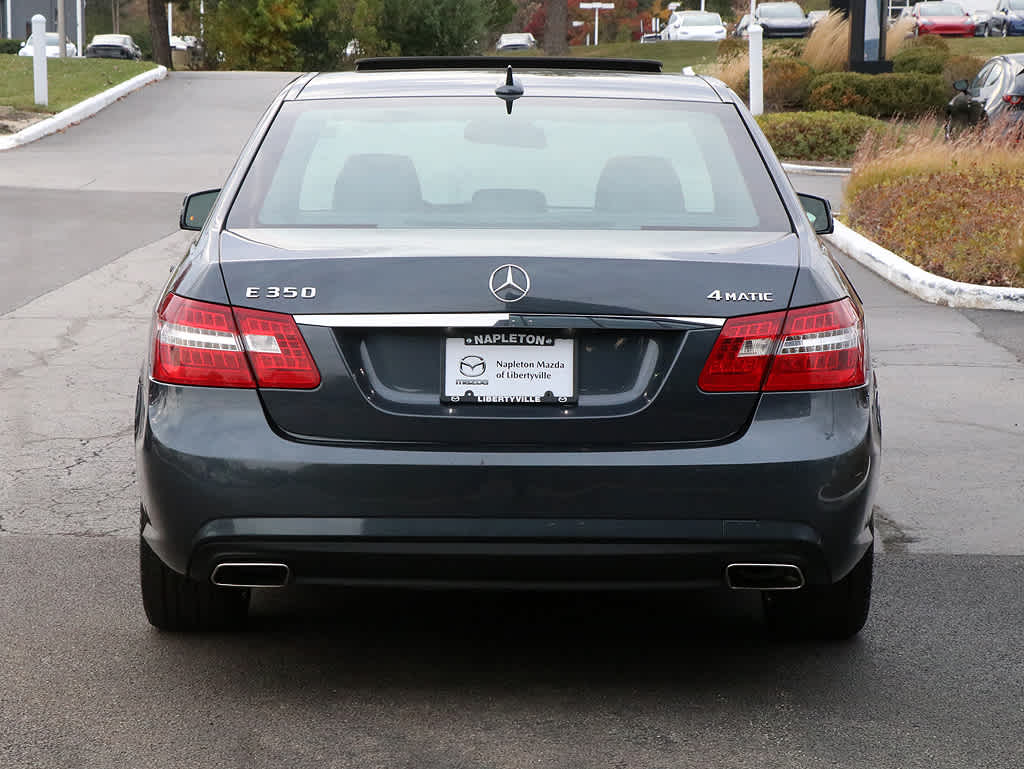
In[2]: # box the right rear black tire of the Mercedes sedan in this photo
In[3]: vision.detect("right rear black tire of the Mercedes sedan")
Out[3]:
[762,546,874,641]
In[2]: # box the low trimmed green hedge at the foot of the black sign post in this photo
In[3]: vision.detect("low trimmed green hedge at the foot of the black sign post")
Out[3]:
[807,72,951,118]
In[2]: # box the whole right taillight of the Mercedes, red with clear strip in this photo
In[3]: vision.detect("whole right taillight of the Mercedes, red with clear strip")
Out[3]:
[698,299,865,392]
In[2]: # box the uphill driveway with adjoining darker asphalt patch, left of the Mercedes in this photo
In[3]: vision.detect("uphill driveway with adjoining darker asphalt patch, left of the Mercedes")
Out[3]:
[0,73,295,313]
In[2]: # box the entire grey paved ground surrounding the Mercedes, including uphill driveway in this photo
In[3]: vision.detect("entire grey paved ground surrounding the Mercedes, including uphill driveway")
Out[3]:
[0,73,1024,767]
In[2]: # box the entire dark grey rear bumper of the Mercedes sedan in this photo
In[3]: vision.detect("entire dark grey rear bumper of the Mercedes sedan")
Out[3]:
[136,382,880,587]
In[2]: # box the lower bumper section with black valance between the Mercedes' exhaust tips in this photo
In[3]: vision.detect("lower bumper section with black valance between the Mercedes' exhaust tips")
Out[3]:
[188,518,839,589]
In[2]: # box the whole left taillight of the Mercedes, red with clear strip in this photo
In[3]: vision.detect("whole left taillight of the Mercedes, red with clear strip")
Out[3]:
[153,294,319,388]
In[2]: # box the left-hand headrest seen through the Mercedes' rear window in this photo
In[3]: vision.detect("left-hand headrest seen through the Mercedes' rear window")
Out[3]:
[334,155,423,213]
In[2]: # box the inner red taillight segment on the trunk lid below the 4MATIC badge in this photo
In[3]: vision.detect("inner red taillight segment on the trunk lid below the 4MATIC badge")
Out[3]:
[697,312,785,392]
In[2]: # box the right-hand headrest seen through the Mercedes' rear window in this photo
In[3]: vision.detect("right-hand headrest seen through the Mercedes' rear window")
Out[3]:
[594,155,686,214]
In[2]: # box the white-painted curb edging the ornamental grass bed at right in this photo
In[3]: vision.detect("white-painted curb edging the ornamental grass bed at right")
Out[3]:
[825,221,1024,312]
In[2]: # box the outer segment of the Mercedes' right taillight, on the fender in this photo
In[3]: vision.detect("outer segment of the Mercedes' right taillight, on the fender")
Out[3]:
[764,299,864,391]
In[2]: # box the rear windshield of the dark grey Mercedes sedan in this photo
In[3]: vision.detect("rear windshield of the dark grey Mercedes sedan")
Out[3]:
[227,96,792,232]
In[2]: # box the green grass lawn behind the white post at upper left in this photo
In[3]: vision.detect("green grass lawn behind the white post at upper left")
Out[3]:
[0,54,156,113]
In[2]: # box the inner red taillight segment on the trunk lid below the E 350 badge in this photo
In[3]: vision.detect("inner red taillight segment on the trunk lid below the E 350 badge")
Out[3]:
[234,307,319,389]
